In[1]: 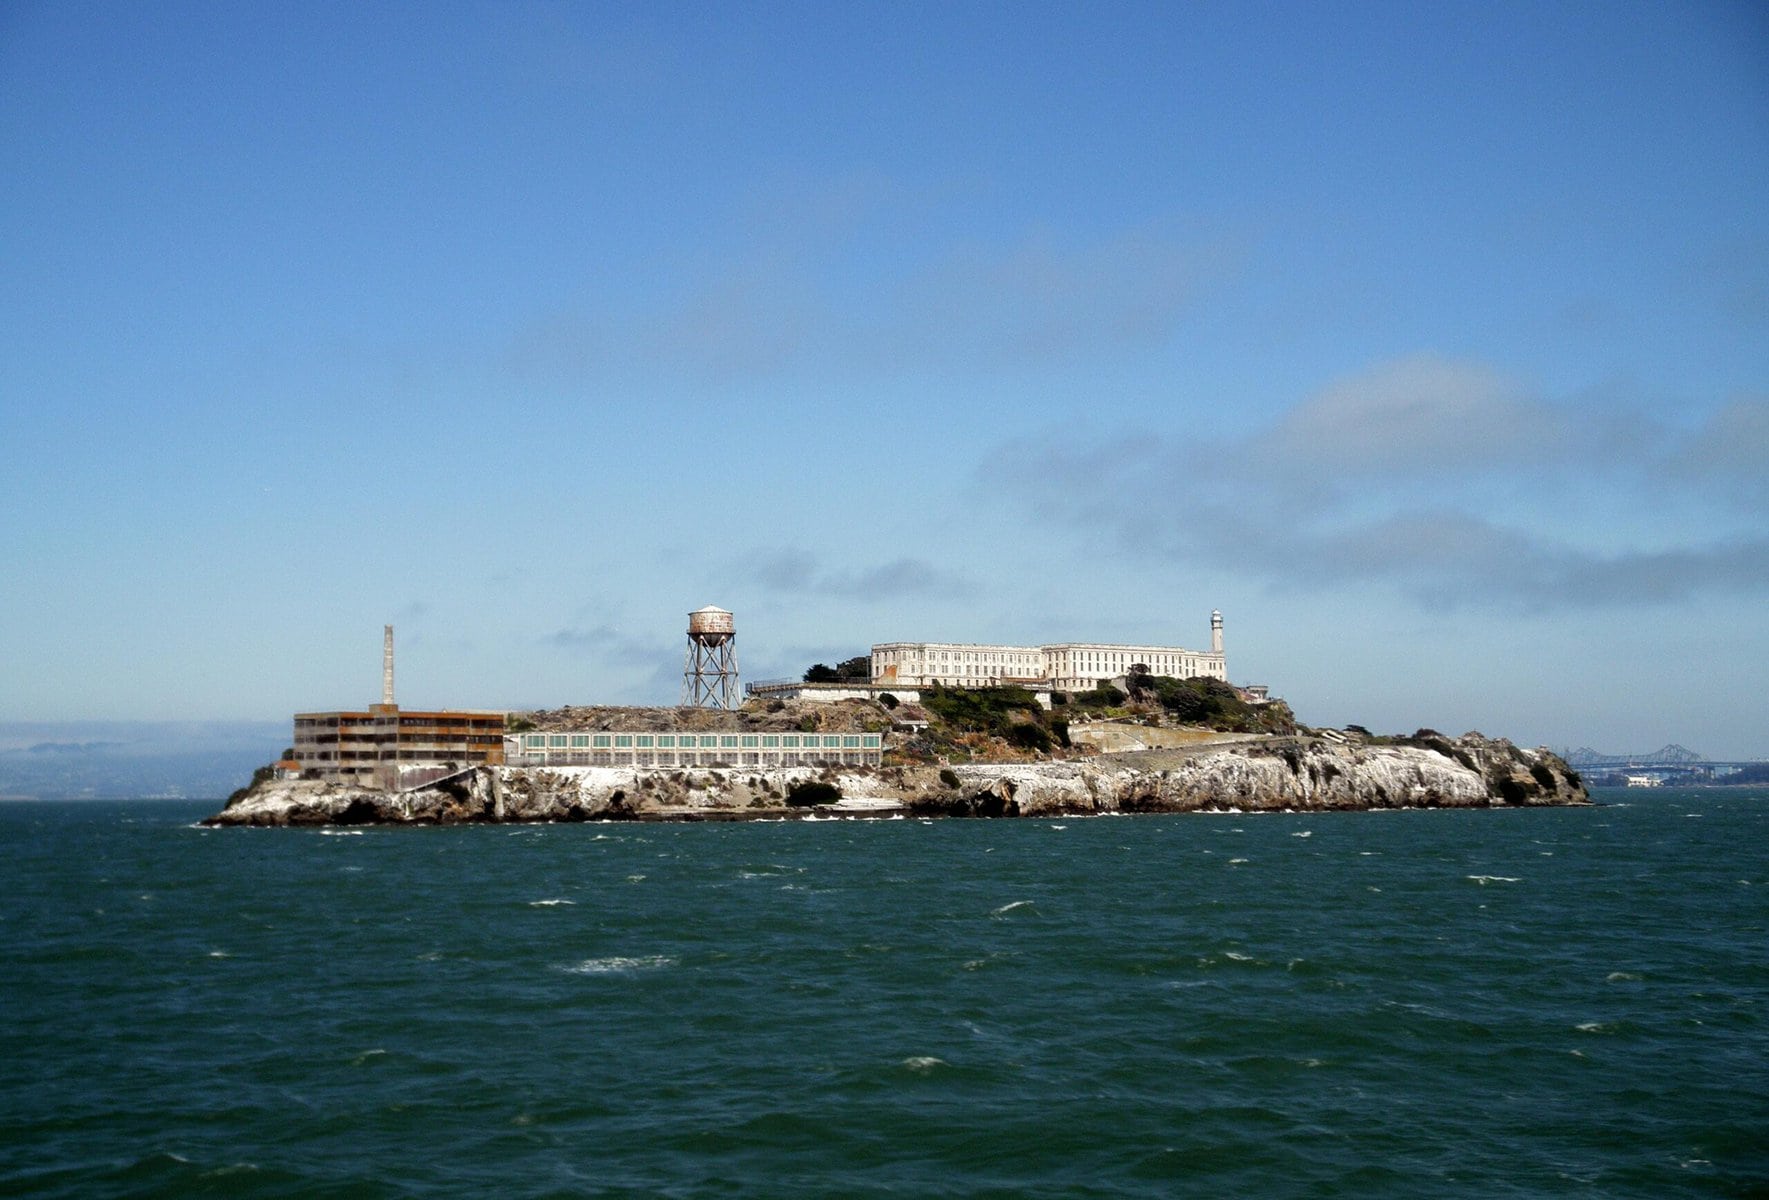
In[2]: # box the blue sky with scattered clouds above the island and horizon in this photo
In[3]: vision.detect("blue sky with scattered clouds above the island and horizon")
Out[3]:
[0,0,1769,758]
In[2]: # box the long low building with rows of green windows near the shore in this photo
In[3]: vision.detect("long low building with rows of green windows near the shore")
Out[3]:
[504,729,885,768]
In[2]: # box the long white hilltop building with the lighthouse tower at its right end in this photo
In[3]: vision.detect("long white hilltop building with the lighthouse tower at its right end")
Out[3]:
[872,612,1228,690]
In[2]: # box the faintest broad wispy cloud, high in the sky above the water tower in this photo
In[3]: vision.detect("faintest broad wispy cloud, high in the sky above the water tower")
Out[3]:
[509,186,1247,384]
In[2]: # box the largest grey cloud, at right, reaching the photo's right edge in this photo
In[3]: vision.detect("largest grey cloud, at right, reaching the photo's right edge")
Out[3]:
[985,358,1769,611]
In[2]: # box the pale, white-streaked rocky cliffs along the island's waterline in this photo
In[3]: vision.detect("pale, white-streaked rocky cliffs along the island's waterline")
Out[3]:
[205,729,1590,825]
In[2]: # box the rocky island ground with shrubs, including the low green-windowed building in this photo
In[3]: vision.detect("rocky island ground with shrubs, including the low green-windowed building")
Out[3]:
[207,676,1590,825]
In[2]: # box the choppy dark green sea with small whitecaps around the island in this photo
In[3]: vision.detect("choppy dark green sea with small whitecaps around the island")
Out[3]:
[0,789,1769,1198]
